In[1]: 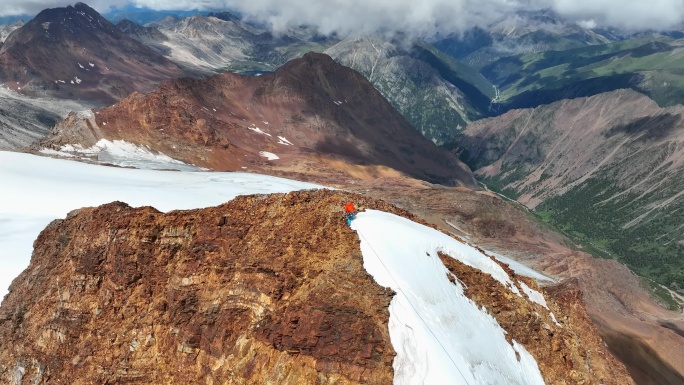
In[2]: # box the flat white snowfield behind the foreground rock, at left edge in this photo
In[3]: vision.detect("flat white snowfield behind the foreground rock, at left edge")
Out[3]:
[0,151,321,298]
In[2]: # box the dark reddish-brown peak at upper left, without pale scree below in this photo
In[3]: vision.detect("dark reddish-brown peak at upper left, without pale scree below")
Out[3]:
[0,3,182,103]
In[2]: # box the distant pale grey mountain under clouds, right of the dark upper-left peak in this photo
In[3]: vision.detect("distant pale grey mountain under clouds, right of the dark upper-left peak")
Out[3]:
[117,12,336,73]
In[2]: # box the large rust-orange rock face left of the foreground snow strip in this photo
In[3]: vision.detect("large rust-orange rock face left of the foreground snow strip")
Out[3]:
[0,191,394,384]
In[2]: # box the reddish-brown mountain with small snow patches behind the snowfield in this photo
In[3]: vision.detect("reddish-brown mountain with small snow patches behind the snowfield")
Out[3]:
[41,53,475,186]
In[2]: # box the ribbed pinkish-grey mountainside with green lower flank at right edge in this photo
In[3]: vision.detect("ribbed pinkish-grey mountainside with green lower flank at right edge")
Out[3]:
[457,90,684,290]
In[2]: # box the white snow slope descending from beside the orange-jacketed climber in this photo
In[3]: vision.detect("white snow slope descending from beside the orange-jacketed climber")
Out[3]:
[352,210,544,385]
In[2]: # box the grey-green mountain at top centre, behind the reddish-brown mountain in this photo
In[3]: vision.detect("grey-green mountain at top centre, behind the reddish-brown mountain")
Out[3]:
[325,36,495,143]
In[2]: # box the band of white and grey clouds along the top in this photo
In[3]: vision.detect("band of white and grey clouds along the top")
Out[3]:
[0,0,684,35]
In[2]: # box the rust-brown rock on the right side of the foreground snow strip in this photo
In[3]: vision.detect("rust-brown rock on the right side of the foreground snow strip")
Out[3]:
[440,254,634,385]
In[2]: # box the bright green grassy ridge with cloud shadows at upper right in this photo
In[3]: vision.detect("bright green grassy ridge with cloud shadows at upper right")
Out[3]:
[482,36,684,110]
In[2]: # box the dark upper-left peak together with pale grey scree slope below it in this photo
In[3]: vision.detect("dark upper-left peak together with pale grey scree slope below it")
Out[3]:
[0,3,182,150]
